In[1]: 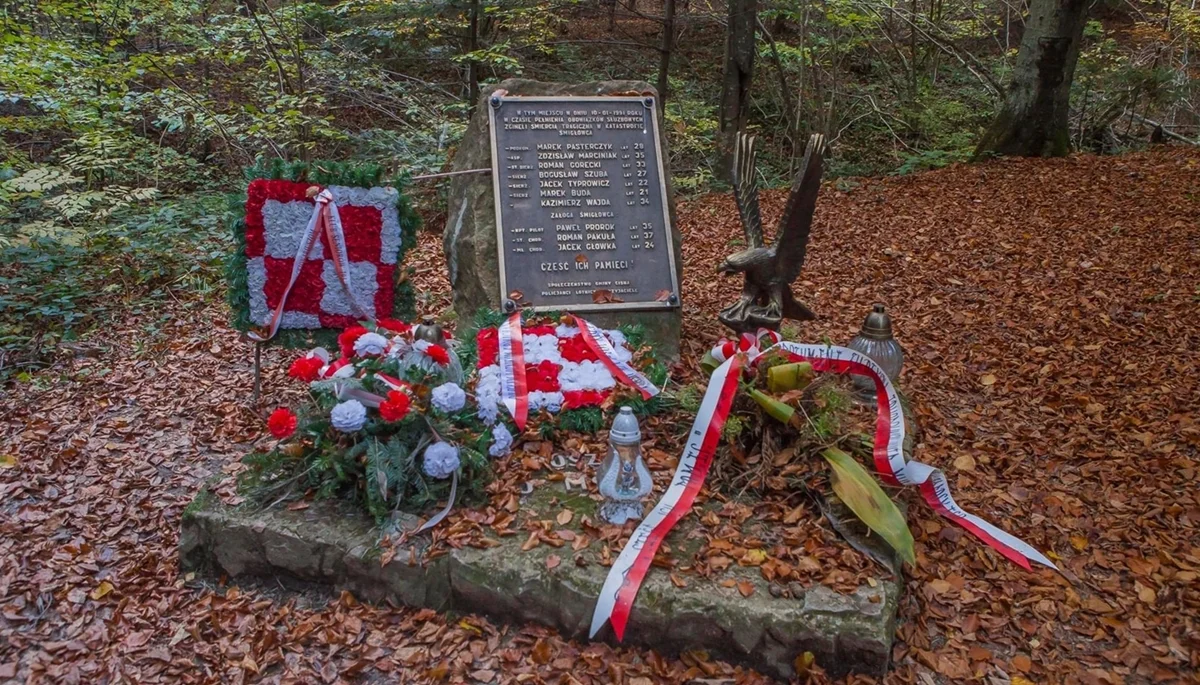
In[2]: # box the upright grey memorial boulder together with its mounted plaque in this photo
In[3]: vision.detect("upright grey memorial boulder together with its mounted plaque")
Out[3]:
[444,79,680,357]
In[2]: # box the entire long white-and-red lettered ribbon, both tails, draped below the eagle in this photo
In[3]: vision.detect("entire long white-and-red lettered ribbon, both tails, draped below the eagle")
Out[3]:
[590,336,1058,641]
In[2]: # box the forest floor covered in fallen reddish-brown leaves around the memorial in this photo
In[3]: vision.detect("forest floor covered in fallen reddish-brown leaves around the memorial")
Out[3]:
[0,149,1200,685]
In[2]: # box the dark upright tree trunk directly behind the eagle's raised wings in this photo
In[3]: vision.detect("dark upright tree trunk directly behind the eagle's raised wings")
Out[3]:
[716,0,758,180]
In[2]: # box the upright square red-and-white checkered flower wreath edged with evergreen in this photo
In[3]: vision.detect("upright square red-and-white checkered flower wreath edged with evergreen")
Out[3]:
[230,159,415,340]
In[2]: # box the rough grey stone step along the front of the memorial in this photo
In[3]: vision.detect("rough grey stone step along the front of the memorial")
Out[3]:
[180,493,900,679]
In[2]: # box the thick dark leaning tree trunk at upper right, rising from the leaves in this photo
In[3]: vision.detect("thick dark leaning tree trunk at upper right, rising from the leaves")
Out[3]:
[974,0,1091,160]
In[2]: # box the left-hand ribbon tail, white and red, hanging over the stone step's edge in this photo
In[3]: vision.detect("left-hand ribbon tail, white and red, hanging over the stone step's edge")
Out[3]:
[590,355,745,641]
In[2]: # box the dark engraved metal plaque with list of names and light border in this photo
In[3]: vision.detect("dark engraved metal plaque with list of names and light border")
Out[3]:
[488,95,679,312]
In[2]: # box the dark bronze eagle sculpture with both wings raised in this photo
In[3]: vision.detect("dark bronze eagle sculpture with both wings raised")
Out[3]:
[718,133,826,334]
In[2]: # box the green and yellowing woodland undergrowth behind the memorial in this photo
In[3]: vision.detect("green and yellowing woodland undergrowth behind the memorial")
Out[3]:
[0,0,1200,379]
